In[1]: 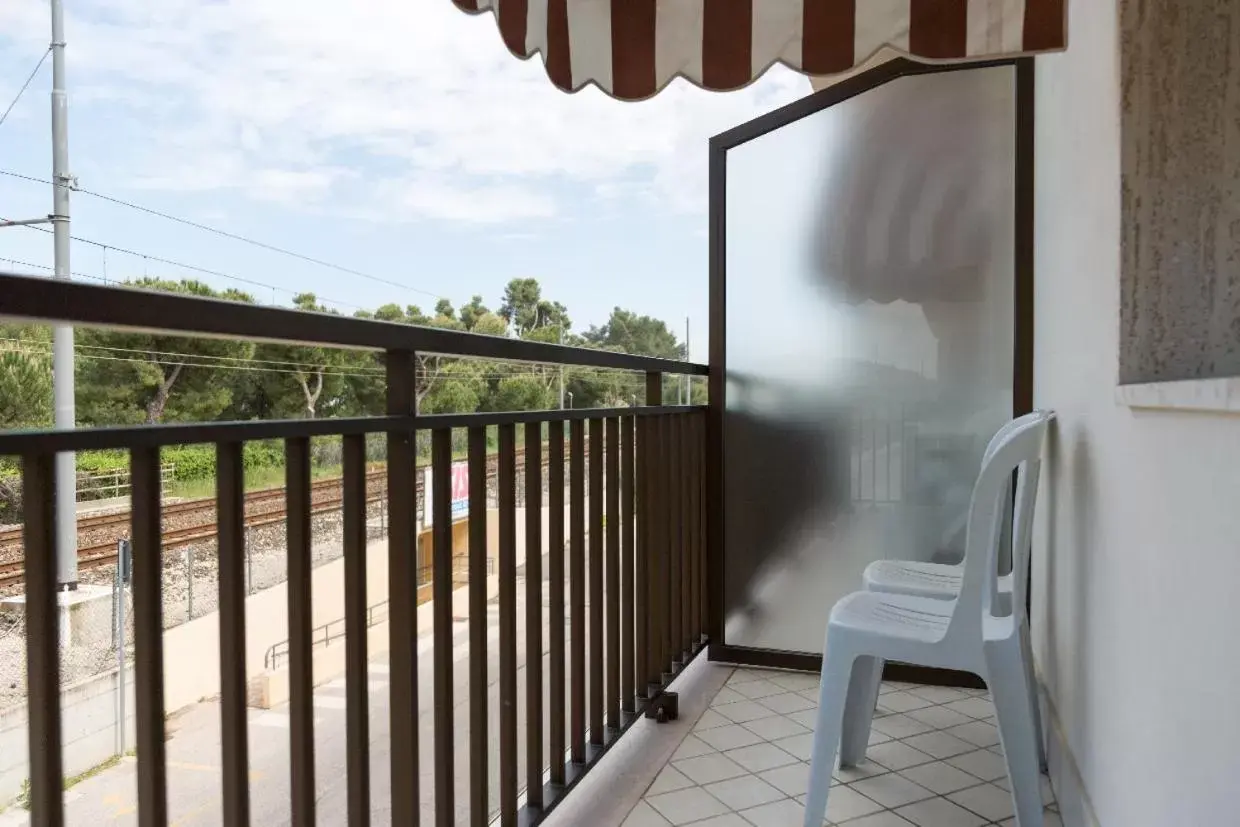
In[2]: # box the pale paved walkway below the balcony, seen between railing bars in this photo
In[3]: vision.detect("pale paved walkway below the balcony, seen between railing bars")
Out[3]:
[14,565,568,827]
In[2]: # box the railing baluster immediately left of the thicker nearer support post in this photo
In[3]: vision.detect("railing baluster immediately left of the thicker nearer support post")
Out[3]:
[342,434,371,827]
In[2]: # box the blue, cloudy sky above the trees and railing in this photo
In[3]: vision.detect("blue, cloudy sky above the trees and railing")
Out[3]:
[0,0,810,361]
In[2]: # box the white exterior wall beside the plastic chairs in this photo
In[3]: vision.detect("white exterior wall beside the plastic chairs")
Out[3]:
[1033,0,1240,827]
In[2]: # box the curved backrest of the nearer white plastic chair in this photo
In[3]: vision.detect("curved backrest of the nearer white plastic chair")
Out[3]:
[949,412,1053,636]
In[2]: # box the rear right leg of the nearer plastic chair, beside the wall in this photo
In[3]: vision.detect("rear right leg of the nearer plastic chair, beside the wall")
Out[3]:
[986,636,1043,827]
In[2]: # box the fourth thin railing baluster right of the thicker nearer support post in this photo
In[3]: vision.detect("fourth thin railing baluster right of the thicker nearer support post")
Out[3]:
[526,423,543,808]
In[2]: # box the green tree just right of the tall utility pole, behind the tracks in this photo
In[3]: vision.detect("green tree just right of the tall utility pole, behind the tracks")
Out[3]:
[76,279,254,425]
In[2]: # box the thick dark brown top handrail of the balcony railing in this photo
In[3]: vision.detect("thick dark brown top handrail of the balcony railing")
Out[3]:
[0,272,708,376]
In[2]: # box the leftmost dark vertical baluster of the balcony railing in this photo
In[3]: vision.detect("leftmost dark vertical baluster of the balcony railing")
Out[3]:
[21,451,64,827]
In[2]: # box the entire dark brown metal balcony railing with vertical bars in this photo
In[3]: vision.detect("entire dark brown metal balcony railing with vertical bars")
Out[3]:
[0,275,707,827]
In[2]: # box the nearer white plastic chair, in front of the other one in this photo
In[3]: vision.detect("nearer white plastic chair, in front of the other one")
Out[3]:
[805,417,1049,827]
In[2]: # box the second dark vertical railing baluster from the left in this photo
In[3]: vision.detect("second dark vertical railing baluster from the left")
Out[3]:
[129,448,167,827]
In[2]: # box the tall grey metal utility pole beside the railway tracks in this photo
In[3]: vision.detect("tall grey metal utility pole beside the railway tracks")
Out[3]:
[51,0,77,591]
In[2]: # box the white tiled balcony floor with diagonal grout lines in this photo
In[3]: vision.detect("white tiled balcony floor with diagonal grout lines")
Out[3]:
[624,668,1061,827]
